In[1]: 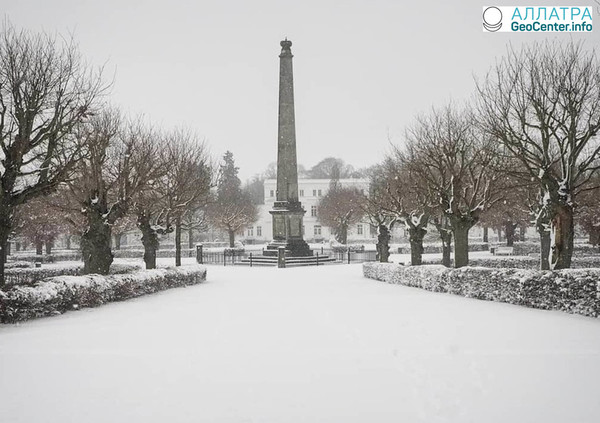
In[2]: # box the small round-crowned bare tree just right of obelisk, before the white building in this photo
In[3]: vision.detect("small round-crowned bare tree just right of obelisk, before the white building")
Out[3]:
[317,184,364,244]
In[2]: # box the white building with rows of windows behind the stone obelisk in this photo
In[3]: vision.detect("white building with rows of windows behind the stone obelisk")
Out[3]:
[240,179,375,244]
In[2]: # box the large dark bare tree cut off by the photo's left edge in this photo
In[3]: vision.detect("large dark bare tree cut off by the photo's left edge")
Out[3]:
[0,24,106,286]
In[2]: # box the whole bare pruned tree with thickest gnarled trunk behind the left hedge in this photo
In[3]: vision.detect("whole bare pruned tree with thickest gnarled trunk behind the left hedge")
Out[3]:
[69,109,164,274]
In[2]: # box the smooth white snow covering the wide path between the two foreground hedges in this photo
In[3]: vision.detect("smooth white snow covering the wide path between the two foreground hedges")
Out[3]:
[0,260,600,423]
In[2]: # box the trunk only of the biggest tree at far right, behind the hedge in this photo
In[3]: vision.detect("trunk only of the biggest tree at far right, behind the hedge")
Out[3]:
[550,204,575,270]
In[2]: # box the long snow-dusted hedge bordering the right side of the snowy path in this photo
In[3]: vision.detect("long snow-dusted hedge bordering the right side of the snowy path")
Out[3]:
[363,263,600,317]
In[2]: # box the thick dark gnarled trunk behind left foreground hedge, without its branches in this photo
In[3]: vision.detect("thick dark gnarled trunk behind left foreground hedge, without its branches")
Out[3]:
[81,210,114,275]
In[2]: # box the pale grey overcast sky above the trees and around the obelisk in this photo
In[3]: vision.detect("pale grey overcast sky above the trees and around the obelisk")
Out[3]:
[0,0,600,179]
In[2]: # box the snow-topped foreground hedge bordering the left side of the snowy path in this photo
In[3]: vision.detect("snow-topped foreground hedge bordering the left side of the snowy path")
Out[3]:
[0,266,206,323]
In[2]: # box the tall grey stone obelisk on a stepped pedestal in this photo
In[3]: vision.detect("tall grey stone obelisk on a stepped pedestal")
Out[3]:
[265,38,312,257]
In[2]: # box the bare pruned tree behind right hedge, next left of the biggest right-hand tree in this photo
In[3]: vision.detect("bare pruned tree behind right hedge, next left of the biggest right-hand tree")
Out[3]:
[401,105,501,267]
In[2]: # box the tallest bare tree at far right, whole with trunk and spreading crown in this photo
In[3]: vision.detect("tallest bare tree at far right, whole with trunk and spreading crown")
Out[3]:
[477,42,600,269]
